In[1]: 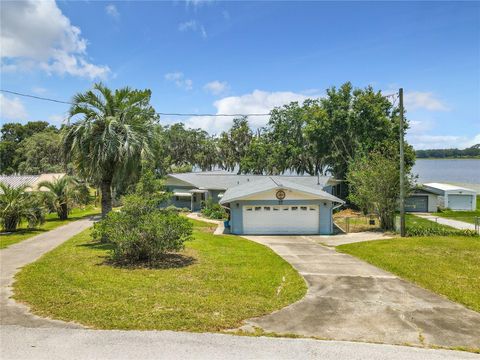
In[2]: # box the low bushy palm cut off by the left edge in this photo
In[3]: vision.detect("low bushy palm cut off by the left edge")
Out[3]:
[0,182,44,232]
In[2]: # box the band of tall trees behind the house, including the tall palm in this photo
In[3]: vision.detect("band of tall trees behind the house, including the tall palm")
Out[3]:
[0,83,415,222]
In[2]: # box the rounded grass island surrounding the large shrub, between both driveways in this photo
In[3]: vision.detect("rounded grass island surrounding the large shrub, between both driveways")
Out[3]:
[14,221,306,331]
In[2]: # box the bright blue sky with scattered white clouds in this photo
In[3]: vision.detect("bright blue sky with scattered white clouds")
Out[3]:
[0,0,480,149]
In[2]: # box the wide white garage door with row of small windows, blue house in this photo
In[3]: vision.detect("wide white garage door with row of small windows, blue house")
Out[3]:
[243,205,320,234]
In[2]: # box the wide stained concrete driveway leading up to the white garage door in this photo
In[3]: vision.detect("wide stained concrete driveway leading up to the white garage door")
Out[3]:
[242,236,480,348]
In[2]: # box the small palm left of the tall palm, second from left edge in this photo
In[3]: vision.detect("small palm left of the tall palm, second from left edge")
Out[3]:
[38,176,85,220]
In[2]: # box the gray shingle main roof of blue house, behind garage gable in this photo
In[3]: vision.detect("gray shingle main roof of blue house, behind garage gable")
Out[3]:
[167,171,335,190]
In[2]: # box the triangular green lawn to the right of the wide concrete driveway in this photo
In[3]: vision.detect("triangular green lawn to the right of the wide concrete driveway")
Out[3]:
[336,236,480,311]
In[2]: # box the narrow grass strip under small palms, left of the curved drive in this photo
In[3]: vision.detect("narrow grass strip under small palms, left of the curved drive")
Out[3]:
[0,206,100,249]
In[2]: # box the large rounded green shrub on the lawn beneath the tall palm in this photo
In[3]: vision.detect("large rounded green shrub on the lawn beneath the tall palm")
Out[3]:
[93,194,192,265]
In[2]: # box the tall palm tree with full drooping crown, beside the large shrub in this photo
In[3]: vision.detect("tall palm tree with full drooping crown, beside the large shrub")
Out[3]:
[63,83,158,218]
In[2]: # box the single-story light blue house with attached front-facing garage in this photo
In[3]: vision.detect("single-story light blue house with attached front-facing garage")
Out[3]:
[166,172,344,234]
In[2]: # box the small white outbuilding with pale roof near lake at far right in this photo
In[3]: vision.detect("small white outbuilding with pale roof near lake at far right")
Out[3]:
[423,183,477,211]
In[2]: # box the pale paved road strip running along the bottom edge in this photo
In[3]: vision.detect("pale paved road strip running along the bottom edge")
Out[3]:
[0,326,479,360]
